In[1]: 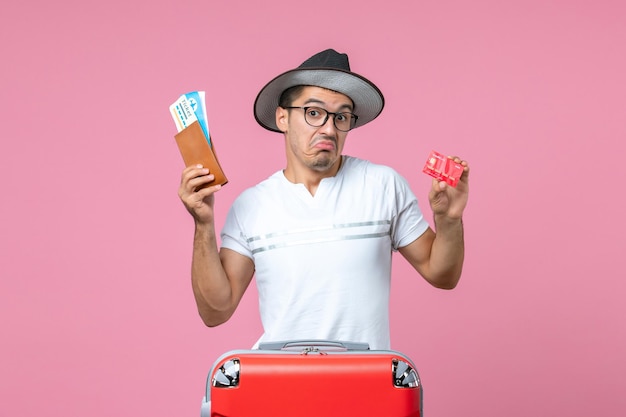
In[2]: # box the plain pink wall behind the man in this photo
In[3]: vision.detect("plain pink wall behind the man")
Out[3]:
[0,0,626,417]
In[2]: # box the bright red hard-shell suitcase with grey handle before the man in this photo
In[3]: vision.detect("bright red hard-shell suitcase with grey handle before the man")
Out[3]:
[201,341,423,417]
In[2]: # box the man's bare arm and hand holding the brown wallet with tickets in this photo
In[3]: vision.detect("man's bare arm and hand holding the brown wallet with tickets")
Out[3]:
[178,167,254,326]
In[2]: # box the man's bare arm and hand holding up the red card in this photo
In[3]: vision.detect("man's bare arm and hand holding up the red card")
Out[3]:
[399,157,469,289]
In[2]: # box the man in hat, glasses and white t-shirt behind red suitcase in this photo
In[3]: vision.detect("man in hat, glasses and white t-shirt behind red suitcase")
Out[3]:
[179,50,469,349]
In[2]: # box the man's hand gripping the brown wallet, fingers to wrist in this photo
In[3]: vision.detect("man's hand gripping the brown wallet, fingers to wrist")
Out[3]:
[178,165,222,224]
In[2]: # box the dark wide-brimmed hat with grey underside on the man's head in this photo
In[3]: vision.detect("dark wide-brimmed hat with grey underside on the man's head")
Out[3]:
[254,49,385,132]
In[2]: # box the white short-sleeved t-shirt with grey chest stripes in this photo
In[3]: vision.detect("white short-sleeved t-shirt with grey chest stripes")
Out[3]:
[221,156,429,349]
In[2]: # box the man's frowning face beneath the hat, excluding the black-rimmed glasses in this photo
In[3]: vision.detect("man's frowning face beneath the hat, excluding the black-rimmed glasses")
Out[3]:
[276,87,353,172]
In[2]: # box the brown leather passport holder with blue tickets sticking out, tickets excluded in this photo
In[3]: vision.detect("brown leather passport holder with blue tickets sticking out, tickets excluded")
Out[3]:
[174,121,228,188]
